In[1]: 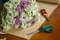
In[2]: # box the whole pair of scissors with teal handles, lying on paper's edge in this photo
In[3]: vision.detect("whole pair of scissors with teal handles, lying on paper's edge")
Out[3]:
[27,25,52,35]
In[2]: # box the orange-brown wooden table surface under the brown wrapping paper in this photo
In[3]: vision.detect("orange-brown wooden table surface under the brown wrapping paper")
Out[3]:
[0,5,60,40]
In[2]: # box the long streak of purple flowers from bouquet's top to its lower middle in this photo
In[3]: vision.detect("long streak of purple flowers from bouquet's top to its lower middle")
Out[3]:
[14,0,29,25]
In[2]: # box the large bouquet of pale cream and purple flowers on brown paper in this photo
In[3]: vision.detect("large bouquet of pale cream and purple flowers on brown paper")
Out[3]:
[0,0,39,31]
